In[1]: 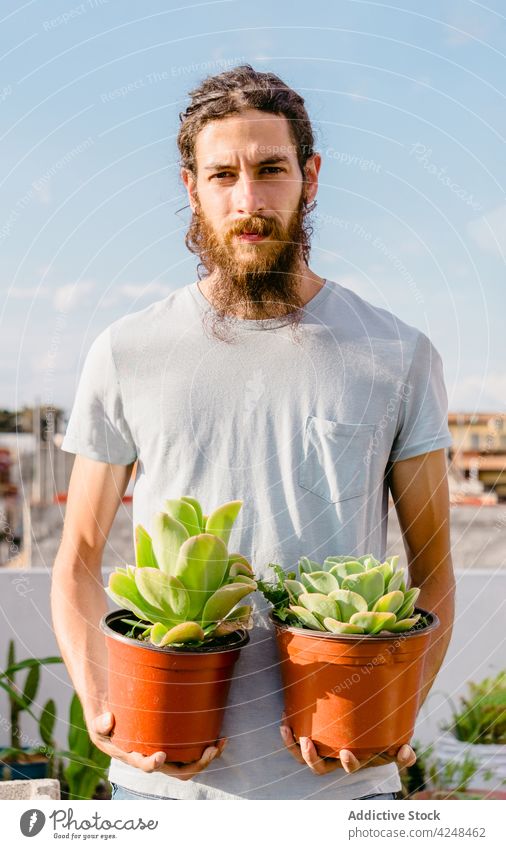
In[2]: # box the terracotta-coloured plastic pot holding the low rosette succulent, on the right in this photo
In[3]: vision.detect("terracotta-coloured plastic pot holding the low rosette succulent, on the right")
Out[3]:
[271,608,439,758]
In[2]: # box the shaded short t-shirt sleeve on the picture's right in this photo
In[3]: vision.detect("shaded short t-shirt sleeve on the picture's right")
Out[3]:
[390,333,452,462]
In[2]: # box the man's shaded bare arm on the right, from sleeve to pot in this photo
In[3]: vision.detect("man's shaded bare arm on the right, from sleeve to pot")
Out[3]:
[389,449,455,705]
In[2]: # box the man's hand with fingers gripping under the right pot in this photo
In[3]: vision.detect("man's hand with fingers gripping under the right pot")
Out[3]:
[280,714,416,775]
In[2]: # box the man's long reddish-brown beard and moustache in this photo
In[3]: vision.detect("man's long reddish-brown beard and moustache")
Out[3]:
[185,192,312,340]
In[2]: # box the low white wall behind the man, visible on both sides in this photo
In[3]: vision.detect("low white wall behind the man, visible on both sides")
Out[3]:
[0,569,506,745]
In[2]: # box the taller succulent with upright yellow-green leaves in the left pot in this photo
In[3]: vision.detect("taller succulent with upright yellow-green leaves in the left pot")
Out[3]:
[106,496,257,646]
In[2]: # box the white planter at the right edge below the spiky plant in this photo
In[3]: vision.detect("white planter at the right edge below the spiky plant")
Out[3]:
[437,733,506,792]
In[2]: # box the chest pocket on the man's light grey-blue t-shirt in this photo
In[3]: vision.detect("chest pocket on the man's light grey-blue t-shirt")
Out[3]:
[299,416,376,503]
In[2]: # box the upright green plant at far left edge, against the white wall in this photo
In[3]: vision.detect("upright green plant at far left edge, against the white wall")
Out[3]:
[0,640,62,761]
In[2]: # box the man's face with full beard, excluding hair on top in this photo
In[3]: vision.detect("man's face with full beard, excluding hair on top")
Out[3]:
[183,109,318,318]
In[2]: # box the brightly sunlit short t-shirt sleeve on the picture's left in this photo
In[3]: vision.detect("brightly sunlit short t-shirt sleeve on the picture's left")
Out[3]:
[61,328,137,466]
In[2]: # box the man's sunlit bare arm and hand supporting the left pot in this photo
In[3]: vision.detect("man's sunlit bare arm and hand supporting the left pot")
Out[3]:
[51,455,226,781]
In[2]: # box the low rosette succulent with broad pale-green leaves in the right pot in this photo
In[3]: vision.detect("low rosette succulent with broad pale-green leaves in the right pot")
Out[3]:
[258,554,426,634]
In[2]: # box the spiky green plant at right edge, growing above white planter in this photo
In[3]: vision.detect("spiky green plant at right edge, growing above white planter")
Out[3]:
[443,670,506,744]
